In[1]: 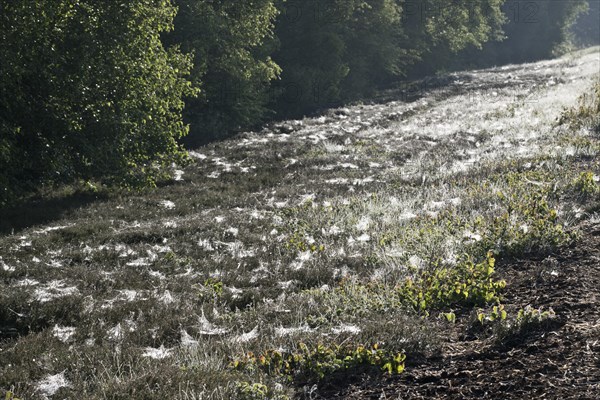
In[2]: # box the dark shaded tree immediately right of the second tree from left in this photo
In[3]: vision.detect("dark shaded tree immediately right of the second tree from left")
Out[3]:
[273,0,362,115]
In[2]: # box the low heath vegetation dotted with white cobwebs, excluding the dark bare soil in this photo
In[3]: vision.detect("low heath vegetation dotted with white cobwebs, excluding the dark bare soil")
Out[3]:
[0,46,600,399]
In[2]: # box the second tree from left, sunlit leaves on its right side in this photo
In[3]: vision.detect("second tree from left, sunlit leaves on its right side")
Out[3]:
[163,0,280,145]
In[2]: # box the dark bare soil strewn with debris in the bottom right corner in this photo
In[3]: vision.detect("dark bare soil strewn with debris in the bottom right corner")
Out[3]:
[314,223,600,400]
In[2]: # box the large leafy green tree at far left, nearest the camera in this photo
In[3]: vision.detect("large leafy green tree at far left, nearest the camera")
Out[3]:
[0,0,195,205]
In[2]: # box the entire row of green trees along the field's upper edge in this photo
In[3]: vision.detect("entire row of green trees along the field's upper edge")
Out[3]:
[0,0,598,204]
